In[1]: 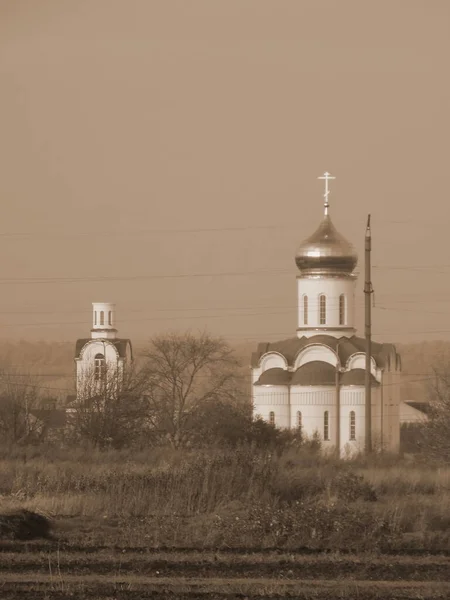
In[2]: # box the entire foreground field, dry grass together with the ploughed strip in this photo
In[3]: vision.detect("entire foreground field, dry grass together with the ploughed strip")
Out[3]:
[0,448,450,599]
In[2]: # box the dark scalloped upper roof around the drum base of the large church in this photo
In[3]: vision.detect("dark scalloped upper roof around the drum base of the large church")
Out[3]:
[251,334,400,369]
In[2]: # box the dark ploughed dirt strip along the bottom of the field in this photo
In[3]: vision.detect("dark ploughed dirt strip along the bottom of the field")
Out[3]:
[0,523,450,600]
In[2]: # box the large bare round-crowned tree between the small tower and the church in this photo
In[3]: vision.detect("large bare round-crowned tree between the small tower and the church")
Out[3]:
[142,333,239,447]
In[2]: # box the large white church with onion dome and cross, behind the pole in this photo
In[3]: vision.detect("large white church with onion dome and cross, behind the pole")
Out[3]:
[251,173,401,456]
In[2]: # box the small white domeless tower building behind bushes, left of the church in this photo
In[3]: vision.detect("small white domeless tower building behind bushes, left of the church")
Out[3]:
[75,302,133,401]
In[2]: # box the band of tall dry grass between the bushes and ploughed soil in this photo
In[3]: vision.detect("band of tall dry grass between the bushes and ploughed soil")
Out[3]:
[0,448,450,549]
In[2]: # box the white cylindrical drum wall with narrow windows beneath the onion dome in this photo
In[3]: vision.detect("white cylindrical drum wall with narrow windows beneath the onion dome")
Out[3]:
[297,277,355,337]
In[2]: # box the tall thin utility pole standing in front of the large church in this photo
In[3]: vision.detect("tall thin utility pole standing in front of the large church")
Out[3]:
[364,215,372,454]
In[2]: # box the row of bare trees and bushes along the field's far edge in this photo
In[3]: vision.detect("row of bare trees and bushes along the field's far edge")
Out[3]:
[0,332,450,460]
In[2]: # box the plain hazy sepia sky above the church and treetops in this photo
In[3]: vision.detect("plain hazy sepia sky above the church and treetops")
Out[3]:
[0,0,450,343]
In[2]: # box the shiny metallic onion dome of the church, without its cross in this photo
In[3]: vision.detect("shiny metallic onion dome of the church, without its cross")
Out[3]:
[295,214,358,275]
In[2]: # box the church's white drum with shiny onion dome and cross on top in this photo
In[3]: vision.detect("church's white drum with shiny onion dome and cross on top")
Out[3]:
[295,173,358,337]
